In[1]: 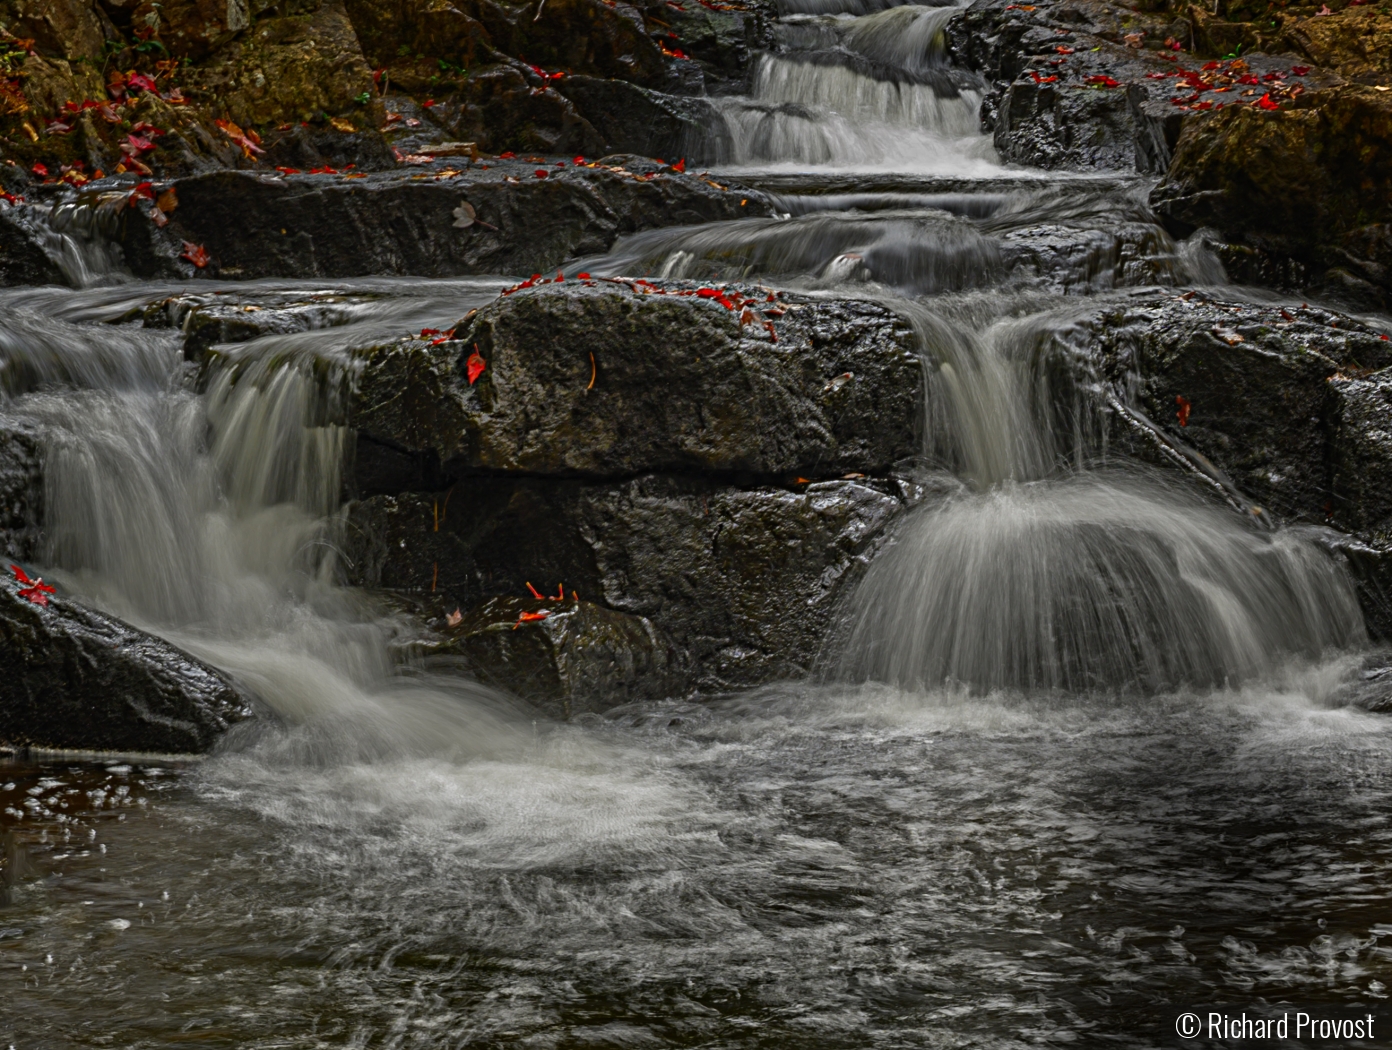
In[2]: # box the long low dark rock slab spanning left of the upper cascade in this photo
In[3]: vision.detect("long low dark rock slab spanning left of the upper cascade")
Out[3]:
[115,160,768,279]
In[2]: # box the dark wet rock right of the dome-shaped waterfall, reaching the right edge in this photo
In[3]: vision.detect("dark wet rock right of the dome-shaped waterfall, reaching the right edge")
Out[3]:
[1066,292,1392,523]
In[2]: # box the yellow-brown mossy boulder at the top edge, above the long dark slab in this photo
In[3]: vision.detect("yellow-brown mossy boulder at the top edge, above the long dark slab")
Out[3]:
[185,0,376,130]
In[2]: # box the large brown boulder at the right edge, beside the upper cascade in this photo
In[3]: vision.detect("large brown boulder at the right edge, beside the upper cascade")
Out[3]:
[1151,85,1392,309]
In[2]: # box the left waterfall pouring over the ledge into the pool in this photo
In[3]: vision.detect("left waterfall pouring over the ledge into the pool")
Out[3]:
[0,281,523,762]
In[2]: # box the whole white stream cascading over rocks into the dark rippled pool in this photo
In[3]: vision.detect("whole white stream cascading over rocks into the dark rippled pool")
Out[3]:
[0,0,1392,1050]
